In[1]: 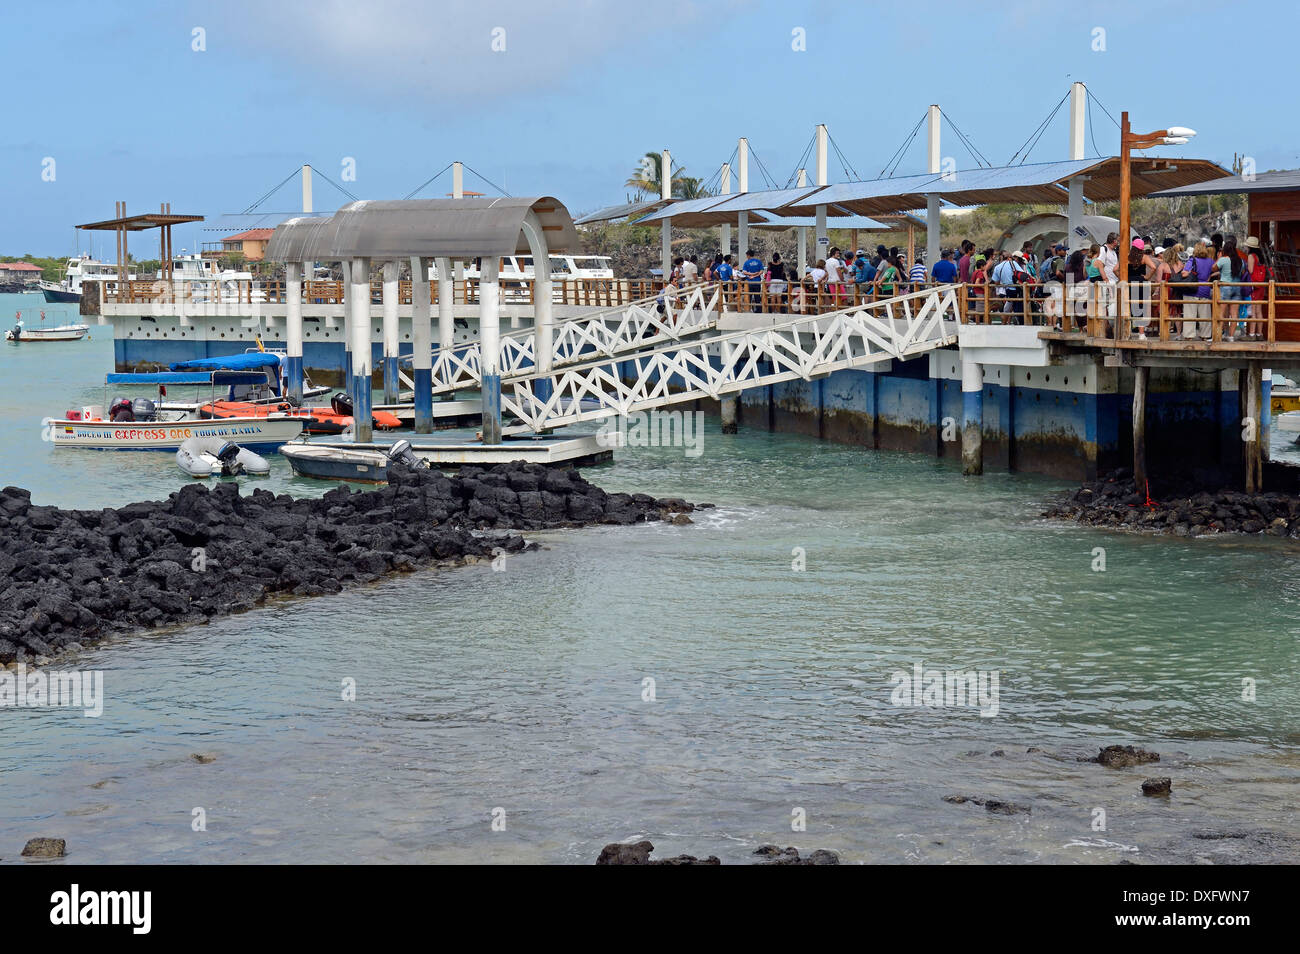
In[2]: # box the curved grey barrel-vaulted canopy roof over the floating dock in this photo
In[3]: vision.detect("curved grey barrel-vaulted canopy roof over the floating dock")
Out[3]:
[267,196,579,261]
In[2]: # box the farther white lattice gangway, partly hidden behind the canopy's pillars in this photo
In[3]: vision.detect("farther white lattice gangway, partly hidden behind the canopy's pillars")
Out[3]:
[398,283,722,394]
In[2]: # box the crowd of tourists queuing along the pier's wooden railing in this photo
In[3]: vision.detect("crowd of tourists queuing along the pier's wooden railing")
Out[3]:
[660,233,1270,341]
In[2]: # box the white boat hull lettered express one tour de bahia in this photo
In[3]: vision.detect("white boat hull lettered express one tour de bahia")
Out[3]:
[42,417,303,454]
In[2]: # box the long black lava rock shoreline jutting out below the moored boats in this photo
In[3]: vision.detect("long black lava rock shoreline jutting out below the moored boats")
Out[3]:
[0,461,707,665]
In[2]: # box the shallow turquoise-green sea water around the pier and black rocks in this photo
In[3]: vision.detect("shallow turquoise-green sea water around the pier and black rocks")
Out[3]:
[0,295,1300,863]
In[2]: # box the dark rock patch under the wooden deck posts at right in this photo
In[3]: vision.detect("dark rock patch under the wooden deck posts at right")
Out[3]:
[1043,471,1300,539]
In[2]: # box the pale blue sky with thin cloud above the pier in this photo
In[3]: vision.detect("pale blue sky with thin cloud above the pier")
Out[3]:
[0,0,1300,257]
